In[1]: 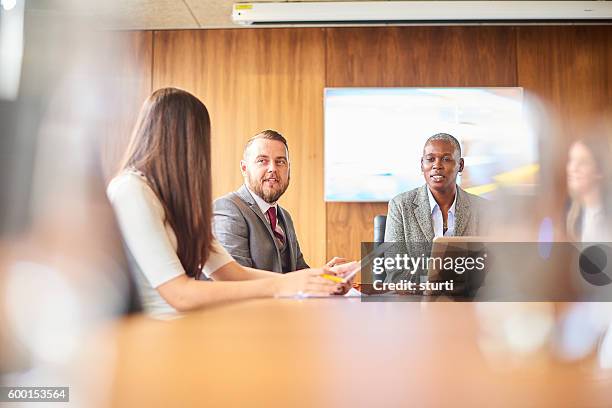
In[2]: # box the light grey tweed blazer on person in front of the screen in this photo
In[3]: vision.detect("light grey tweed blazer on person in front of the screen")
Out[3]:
[385,184,488,281]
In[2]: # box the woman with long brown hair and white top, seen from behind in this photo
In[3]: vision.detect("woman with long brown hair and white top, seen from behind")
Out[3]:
[107,88,339,315]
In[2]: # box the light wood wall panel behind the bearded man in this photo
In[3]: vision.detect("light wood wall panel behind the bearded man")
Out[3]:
[153,28,325,265]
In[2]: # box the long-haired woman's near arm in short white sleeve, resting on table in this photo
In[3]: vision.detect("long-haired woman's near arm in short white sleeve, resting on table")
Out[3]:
[109,176,337,311]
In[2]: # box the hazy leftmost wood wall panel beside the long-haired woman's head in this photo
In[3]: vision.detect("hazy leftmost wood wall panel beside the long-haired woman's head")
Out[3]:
[101,31,153,181]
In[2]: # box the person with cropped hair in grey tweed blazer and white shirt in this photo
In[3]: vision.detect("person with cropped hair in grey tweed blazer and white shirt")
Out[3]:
[385,133,487,282]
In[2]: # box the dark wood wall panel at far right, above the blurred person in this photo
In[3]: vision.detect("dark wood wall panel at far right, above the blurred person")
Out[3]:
[517,26,612,239]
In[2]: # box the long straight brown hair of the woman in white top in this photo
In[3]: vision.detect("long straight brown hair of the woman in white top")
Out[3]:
[120,88,212,277]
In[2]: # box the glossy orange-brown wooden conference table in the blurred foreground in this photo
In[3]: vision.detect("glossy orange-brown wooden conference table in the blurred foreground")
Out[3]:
[105,297,612,407]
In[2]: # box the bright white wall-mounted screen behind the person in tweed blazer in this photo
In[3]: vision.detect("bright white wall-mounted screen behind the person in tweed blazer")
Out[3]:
[324,88,538,201]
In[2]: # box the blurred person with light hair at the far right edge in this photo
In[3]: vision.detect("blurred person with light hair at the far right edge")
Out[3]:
[566,134,612,242]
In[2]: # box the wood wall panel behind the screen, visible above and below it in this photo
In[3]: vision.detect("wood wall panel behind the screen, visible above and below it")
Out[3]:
[326,27,517,258]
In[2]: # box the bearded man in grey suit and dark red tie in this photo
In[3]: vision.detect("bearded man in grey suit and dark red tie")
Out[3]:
[213,129,344,273]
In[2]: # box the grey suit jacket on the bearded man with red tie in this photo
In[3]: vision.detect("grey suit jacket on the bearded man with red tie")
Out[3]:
[213,185,309,272]
